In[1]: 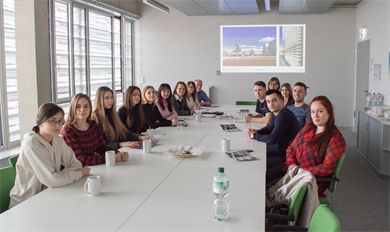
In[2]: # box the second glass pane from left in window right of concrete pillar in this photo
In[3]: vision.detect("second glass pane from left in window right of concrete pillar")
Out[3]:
[73,7,87,93]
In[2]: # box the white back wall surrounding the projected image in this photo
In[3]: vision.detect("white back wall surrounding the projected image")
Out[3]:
[135,1,356,126]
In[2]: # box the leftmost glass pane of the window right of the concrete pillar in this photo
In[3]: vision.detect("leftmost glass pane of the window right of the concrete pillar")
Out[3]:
[54,2,71,99]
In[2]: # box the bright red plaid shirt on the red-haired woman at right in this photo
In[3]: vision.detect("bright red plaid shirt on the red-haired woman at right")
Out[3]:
[286,128,346,197]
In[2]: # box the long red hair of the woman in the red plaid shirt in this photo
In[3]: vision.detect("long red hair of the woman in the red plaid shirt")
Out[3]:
[292,96,337,160]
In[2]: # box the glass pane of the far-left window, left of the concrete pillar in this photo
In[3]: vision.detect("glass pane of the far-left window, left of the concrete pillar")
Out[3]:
[3,0,20,143]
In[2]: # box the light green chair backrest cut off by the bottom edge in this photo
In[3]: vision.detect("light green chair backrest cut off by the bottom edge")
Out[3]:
[308,205,340,232]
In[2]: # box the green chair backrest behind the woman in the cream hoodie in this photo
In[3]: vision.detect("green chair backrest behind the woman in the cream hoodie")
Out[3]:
[0,166,16,213]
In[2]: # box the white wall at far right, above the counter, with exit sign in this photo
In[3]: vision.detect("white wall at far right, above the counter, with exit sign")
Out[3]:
[355,0,390,105]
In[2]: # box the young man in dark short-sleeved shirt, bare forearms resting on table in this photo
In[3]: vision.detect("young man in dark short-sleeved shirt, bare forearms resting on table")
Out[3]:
[245,81,272,124]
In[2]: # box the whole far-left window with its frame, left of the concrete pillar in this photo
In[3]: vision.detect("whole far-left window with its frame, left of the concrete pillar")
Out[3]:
[0,0,20,150]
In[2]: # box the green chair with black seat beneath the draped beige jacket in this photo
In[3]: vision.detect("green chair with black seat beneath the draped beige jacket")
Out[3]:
[266,185,307,226]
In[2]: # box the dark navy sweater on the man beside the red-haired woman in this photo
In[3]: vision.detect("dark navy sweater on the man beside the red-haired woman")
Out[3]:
[253,108,301,155]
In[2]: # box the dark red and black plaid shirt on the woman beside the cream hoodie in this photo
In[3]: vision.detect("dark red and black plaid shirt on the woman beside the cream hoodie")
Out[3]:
[62,120,118,167]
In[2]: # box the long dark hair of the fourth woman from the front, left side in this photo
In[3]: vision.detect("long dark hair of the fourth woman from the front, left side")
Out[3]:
[121,85,144,129]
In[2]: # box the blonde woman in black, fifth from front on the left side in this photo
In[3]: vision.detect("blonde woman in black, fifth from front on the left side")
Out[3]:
[142,86,177,129]
